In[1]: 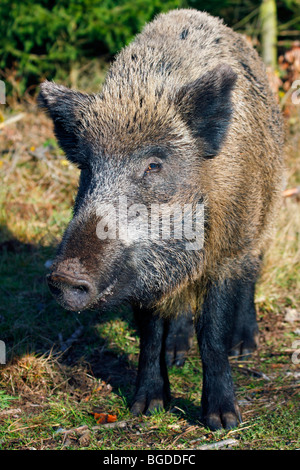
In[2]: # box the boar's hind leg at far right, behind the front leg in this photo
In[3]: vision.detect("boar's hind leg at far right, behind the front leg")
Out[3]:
[229,281,258,360]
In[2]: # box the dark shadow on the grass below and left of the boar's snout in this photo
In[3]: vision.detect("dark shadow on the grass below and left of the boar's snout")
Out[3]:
[0,226,204,422]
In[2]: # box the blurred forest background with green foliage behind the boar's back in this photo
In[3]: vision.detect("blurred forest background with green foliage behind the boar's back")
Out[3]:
[0,0,300,99]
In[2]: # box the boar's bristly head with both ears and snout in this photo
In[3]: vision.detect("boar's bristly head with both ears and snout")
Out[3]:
[39,65,236,311]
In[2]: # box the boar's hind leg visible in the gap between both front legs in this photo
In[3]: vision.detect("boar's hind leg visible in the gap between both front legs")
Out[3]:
[166,311,195,367]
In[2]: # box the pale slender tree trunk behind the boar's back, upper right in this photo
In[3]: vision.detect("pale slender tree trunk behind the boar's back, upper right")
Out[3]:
[259,0,277,69]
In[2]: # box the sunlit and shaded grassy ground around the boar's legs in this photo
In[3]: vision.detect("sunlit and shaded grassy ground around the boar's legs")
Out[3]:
[0,96,300,450]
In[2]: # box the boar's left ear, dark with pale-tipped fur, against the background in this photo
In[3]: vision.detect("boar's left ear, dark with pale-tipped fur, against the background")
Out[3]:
[38,81,90,165]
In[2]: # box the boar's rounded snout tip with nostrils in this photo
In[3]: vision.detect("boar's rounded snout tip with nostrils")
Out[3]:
[47,271,97,311]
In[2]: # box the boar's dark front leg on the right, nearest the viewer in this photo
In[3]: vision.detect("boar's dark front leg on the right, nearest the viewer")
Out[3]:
[196,281,241,430]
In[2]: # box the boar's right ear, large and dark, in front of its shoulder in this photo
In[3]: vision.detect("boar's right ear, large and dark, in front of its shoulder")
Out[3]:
[176,65,237,157]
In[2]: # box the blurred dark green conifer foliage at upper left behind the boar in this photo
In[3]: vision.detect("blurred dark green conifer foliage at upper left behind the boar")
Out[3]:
[0,0,181,94]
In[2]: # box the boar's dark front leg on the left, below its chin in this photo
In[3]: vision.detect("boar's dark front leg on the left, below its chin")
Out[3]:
[131,308,170,415]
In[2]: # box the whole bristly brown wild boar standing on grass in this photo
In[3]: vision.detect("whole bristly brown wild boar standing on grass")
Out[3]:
[39,9,283,430]
